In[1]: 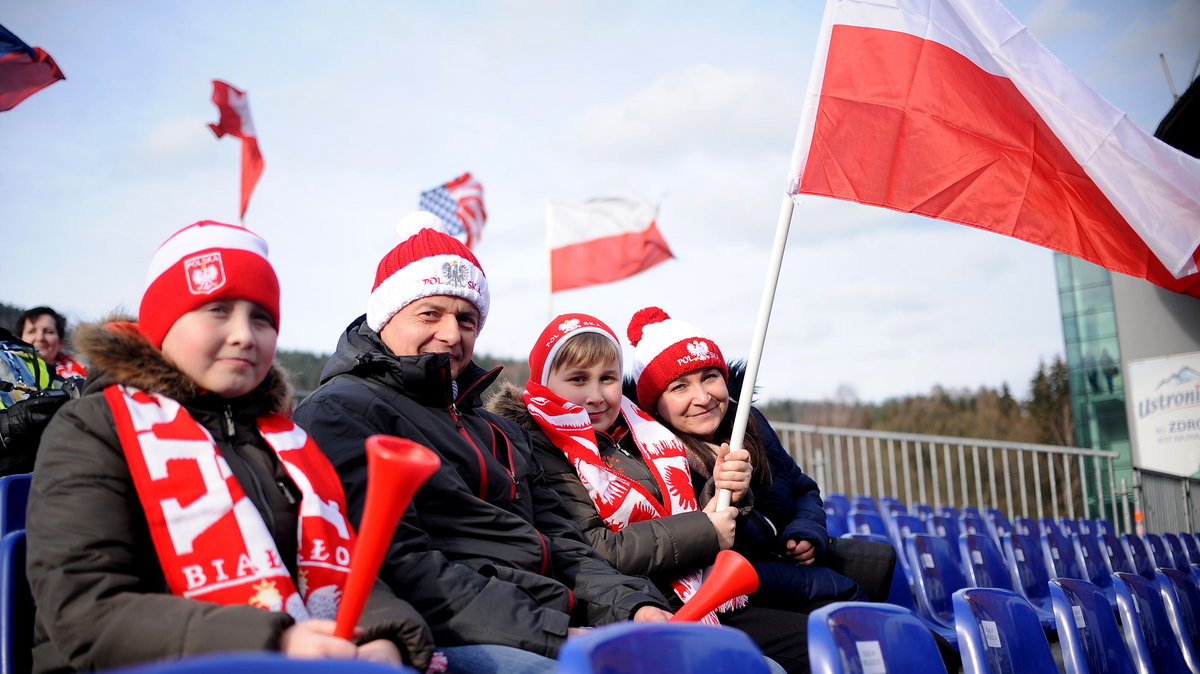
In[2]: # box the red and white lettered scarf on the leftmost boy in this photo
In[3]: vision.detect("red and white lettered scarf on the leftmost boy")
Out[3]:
[104,385,354,621]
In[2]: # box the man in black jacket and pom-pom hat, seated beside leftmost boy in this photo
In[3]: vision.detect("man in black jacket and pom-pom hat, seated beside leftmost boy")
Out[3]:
[288,211,670,669]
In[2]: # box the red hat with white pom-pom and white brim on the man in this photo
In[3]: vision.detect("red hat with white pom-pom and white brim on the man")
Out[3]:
[367,211,491,332]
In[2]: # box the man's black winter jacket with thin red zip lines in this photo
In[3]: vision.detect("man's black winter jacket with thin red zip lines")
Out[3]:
[295,317,666,657]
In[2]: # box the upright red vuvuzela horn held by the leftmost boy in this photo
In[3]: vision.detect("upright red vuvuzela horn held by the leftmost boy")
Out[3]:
[334,435,442,639]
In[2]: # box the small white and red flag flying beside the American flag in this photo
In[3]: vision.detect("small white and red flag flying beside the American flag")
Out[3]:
[546,192,674,293]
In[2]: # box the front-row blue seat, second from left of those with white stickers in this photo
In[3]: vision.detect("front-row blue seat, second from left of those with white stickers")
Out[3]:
[954,588,1057,674]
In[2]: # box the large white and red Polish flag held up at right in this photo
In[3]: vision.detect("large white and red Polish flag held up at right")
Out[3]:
[788,0,1200,297]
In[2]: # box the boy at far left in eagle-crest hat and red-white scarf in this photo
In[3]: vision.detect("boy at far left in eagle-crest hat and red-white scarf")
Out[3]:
[28,221,433,672]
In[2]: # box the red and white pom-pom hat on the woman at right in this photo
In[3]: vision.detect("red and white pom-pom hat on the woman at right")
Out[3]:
[629,307,730,414]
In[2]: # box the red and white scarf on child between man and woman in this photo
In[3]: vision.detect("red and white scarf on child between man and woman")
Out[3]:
[522,381,746,625]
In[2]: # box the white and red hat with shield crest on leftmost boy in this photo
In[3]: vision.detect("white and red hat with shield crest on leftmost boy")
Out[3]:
[138,219,280,348]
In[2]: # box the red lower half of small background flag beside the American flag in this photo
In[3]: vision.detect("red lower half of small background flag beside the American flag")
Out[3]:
[550,222,673,293]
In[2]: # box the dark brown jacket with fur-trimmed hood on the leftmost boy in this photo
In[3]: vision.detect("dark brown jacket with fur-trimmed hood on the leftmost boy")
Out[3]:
[28,325,433,672]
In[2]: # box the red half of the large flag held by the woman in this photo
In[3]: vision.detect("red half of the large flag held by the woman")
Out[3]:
[799,25,1200,296]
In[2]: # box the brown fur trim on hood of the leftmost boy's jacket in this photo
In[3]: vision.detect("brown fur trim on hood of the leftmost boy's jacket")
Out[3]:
[74,317,292,414]
